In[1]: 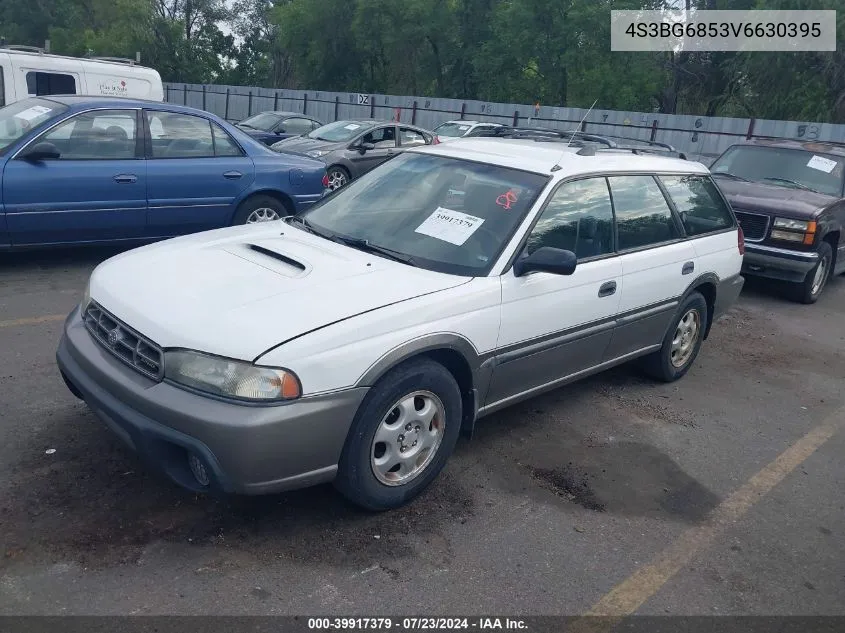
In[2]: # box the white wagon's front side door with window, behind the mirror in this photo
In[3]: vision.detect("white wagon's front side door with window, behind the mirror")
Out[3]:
[486,177,622,406]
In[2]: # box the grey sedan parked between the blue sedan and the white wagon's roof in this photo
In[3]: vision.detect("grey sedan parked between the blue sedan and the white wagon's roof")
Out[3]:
[271,120,435,191]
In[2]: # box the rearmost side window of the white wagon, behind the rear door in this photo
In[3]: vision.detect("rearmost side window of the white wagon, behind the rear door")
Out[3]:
[660,176,733,235]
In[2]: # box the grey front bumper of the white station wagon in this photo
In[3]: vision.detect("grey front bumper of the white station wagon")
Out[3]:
[56,308,367,494]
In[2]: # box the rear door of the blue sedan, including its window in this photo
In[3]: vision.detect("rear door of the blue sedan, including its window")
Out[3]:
[144,110,255,237]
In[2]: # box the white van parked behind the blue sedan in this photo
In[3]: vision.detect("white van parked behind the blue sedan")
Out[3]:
[0,46,164,106]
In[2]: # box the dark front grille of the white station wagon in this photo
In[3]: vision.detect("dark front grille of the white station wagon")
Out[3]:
[83,301,164,380]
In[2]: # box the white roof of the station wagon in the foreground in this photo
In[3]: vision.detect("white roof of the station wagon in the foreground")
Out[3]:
[409,137,710,177]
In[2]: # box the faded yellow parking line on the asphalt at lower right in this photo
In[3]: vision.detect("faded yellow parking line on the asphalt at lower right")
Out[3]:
[579,407,845,631]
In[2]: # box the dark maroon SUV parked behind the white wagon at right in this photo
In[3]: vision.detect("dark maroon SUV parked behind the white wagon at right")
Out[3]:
[711,139,845,303]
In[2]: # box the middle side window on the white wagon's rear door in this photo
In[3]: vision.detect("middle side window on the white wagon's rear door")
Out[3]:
[608,176,680,251]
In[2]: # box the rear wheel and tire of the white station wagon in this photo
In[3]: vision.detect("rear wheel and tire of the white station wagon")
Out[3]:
[642,292,710,382]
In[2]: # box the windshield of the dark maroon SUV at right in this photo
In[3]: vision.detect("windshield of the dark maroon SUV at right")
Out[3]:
[710,145,845,197]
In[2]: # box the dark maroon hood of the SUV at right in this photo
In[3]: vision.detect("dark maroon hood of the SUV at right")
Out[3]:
[714,174,837,218]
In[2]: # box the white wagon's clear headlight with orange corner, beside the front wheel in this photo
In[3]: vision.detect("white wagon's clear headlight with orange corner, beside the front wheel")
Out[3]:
[164,351,302,402]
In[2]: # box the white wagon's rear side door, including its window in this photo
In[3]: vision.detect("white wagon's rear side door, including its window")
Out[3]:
[605,175,699,359]
